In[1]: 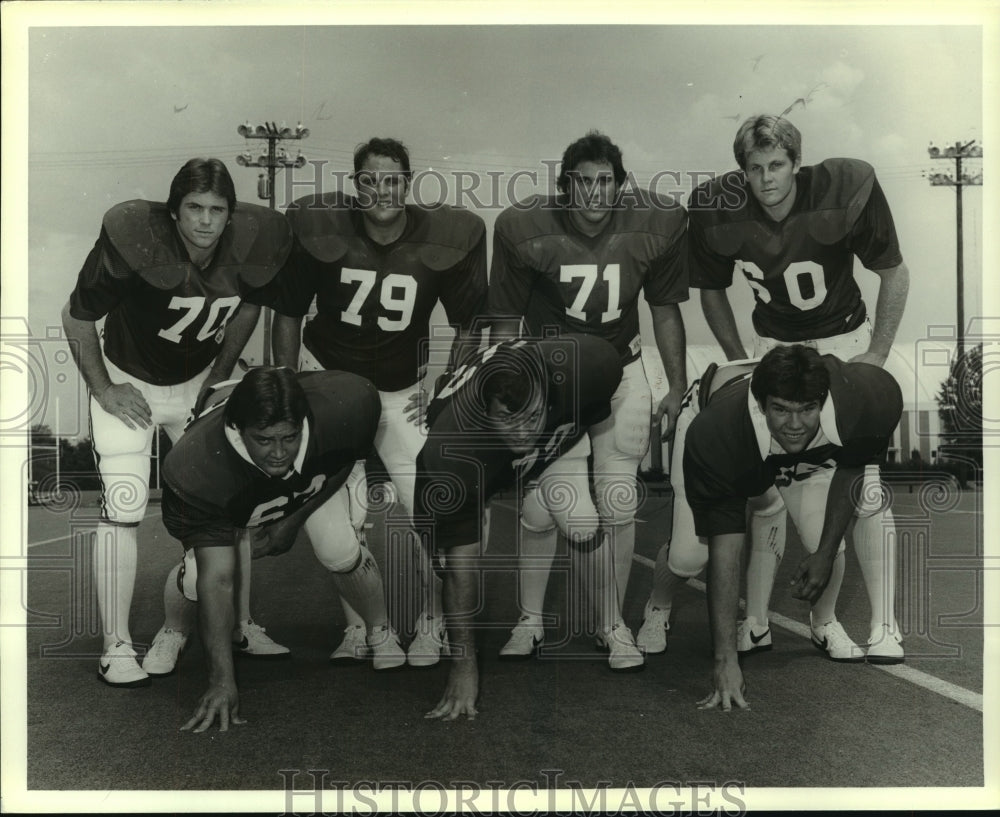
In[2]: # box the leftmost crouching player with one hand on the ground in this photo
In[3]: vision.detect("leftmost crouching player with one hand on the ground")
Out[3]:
[163,367,405,732]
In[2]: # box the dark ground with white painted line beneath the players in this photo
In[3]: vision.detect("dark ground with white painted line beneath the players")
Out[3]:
[5,488,995,811]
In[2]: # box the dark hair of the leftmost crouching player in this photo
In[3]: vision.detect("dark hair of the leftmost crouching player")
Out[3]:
[223,366,309,432]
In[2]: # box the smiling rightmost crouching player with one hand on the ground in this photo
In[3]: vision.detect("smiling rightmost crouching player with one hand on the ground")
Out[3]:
[681,344,903,710]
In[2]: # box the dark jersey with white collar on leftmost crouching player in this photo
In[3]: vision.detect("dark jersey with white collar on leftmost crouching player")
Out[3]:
[162,372,381,548]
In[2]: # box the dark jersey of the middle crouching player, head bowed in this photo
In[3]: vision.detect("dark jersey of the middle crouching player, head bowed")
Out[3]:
[414,335,622,551]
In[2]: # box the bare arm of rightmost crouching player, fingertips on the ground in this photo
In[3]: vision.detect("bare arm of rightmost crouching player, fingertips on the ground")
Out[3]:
[698,533,749,712]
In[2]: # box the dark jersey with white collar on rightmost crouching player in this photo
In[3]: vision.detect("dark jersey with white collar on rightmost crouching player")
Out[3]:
[684,355,903,536]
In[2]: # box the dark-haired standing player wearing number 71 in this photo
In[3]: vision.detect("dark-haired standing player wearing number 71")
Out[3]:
[489,132,688,658]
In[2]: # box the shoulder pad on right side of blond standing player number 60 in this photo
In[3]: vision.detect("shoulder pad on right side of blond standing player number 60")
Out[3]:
[805,159,875,244]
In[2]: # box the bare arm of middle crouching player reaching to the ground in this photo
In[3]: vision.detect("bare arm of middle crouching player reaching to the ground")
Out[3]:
[424,542,479,721]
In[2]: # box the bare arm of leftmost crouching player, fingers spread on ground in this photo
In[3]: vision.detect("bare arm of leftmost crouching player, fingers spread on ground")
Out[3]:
[181,543,246,732]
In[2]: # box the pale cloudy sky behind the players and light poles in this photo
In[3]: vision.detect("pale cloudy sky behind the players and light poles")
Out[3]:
[3,3,984,436]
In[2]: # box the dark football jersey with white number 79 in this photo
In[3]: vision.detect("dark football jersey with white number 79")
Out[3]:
[275,192,486,391]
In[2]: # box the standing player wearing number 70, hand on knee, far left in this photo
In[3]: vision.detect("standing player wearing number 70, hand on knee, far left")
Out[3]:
[62,159,291,687]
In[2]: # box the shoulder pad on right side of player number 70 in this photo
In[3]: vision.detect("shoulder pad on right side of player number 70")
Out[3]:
[216,202,292,288]
